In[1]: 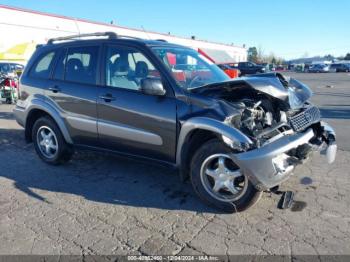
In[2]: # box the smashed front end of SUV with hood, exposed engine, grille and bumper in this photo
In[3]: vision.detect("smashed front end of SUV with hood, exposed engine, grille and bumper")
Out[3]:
[193,73,337,191]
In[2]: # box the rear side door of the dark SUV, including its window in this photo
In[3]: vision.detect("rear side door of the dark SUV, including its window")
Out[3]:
[45,45,100,146]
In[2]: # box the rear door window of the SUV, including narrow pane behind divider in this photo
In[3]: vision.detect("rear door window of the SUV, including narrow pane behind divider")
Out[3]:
[62,46,98,85]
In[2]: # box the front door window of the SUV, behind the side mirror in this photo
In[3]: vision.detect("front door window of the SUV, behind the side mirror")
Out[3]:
[106,46,160,90]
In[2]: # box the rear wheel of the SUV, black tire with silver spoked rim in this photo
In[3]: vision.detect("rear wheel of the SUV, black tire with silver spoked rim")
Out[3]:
[32,116,74,165]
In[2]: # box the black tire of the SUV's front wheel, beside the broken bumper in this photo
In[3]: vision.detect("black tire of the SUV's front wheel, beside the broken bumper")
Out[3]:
[190,139,262,213]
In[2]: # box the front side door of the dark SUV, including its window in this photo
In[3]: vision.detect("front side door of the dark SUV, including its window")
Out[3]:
[97,45,176,162]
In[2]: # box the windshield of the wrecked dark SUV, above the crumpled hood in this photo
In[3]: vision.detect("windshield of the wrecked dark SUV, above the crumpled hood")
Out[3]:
[153,47,230,89]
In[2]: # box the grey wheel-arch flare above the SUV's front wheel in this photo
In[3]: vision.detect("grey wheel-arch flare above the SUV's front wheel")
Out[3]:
[176,117,253,178]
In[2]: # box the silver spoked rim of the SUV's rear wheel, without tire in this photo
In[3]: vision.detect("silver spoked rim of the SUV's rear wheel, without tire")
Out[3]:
[37,126,58,158]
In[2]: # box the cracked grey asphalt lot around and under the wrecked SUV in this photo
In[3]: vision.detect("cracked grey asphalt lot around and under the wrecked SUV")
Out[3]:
[0,74,350,258]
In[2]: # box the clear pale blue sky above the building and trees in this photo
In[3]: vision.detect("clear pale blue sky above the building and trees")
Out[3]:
[0,0,350,59]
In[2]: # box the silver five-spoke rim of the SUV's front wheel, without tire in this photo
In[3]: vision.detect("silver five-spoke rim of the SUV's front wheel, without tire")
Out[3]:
[200,154,248,202]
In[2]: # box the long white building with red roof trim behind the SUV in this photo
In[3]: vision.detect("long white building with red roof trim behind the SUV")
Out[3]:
[0,5,247,63]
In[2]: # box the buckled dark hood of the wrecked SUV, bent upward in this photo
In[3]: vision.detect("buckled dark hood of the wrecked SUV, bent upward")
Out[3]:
[189,73,312,108]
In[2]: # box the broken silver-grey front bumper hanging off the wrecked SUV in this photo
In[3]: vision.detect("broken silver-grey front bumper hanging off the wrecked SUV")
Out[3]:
[231,122,337,190]
